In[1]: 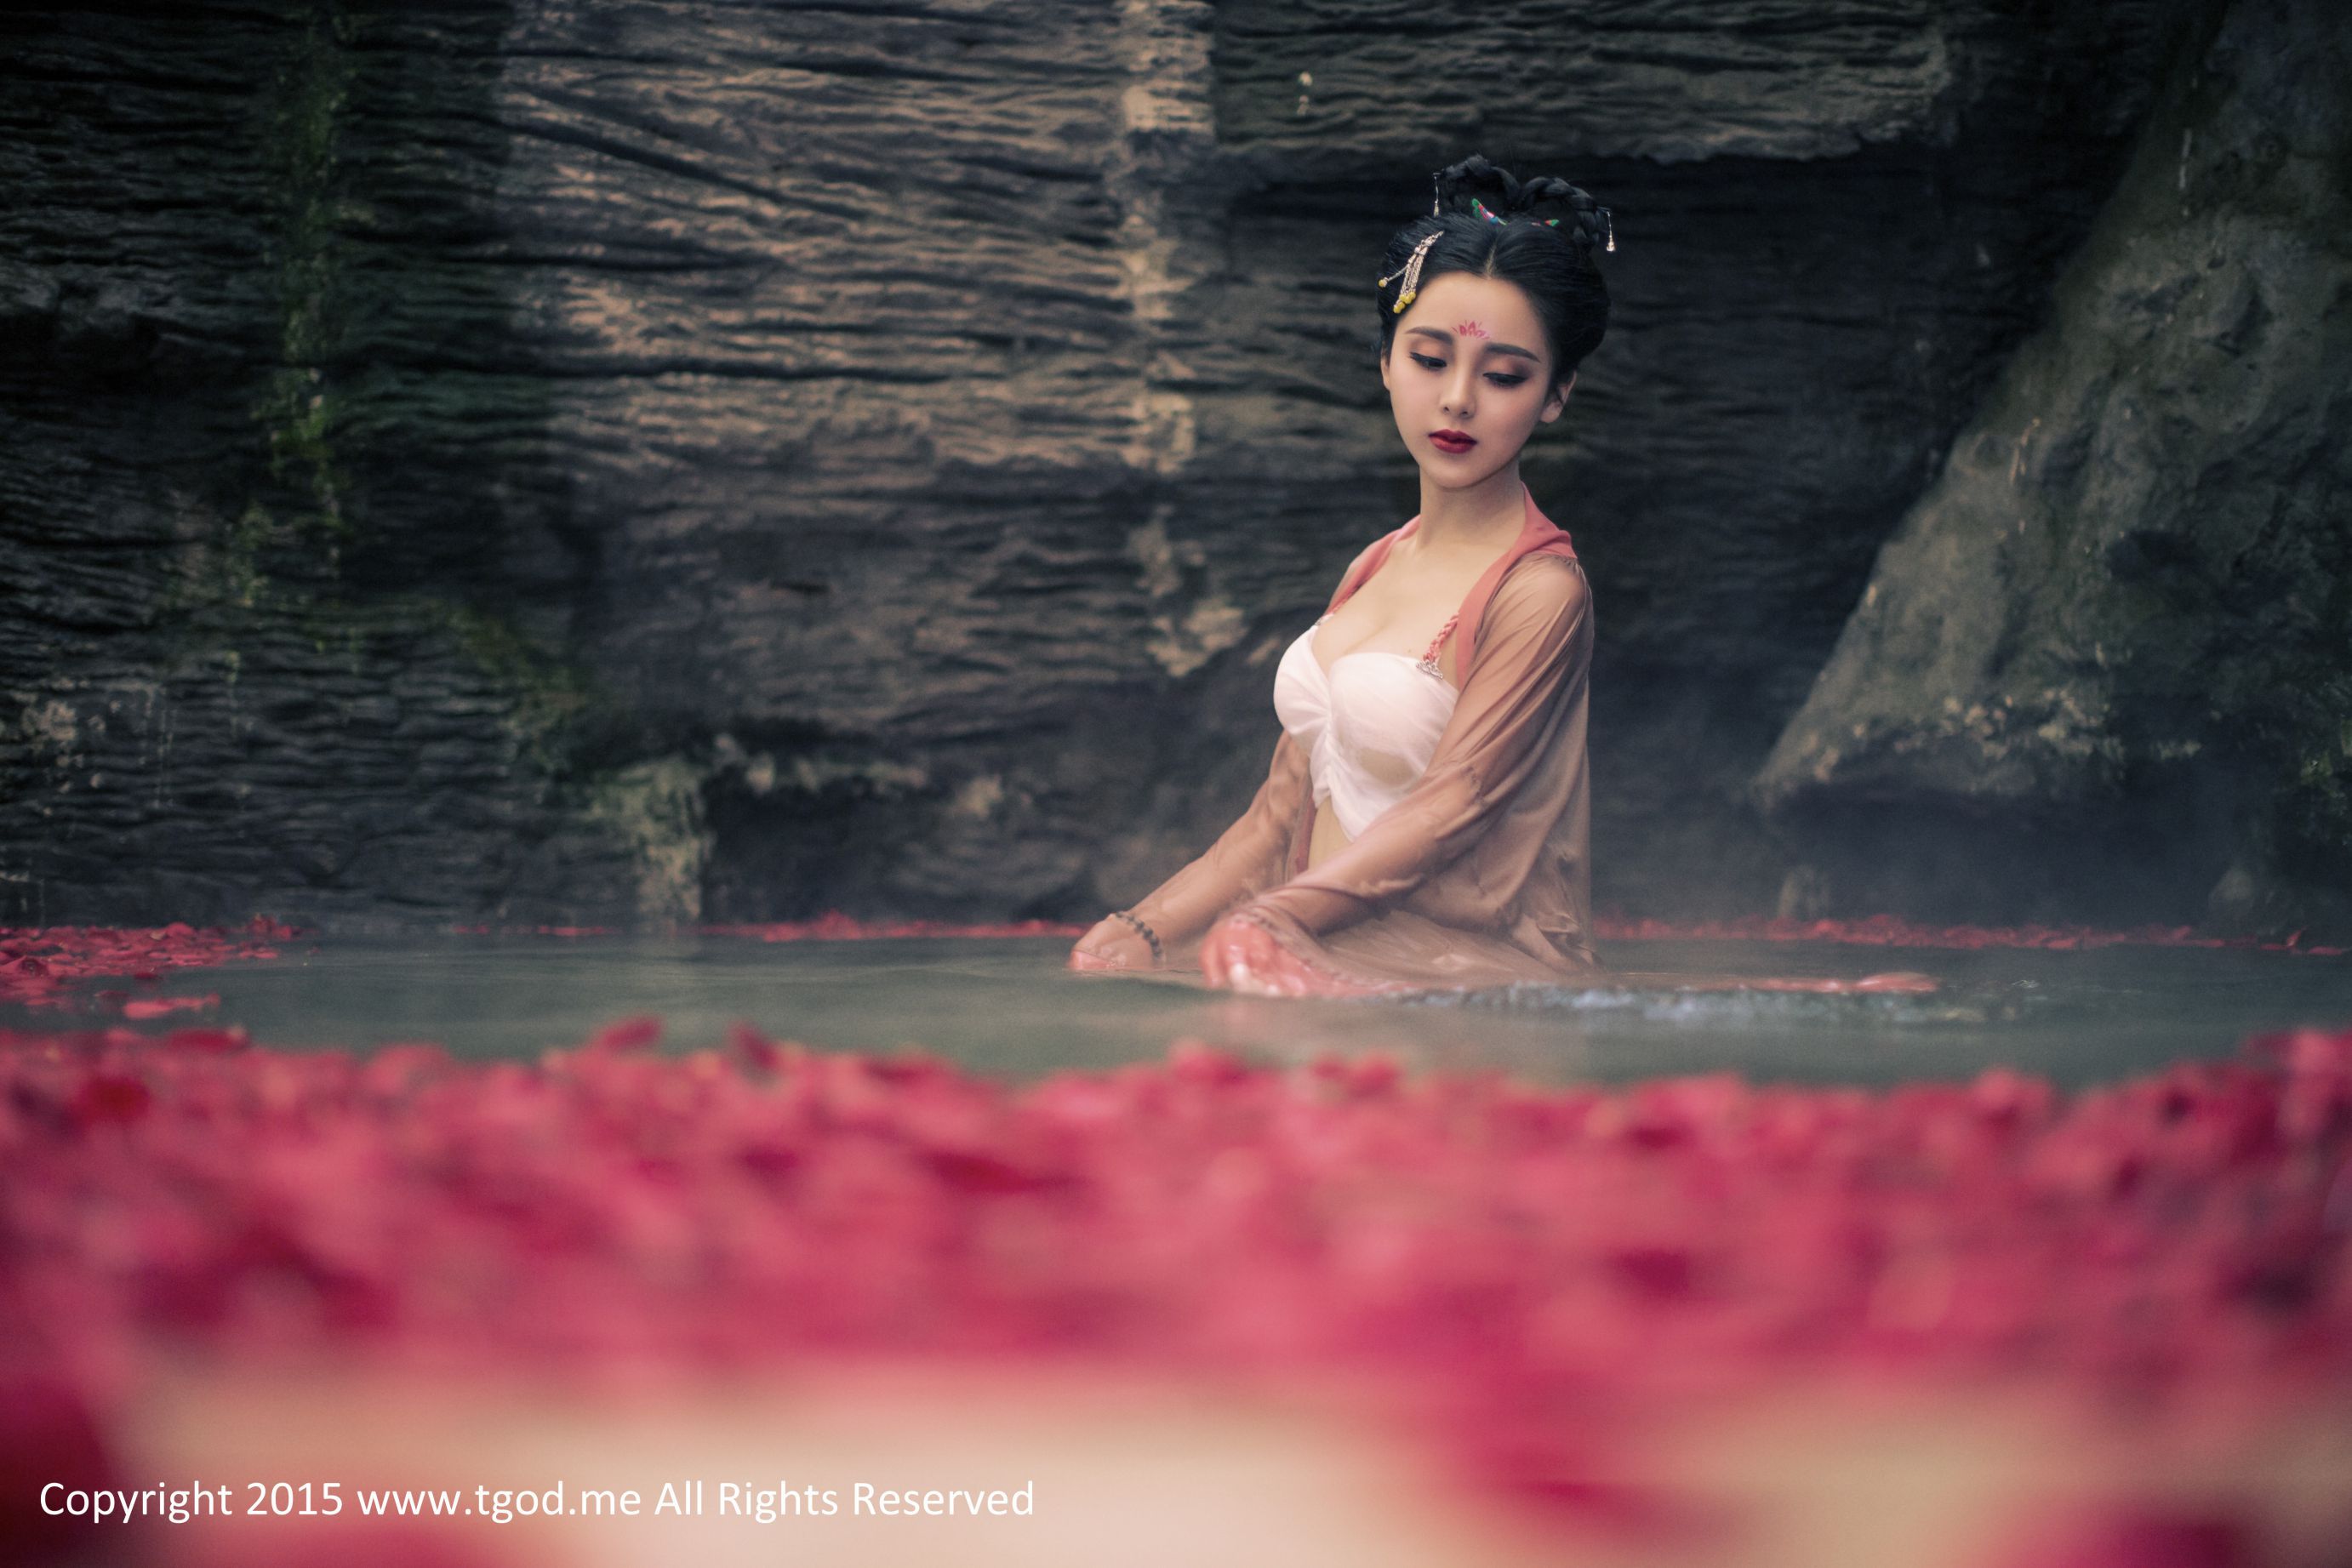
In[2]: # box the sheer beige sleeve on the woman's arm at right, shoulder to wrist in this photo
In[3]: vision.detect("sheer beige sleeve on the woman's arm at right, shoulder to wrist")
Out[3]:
[1242,557,1592,936]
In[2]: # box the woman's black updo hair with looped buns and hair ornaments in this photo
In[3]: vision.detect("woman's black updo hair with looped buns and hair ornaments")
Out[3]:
[1373,157,1611,388]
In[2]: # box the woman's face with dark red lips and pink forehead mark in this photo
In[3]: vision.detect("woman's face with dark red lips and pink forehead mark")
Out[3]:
[1380,273,1576,489]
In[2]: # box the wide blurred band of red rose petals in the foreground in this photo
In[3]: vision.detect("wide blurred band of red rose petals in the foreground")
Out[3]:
[0,1020,2352,1551]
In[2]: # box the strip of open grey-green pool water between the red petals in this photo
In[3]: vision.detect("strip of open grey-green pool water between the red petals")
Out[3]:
[37,936,2352,1084]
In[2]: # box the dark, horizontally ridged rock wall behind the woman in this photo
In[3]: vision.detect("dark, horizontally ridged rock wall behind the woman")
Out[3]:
[0,0,2256,921]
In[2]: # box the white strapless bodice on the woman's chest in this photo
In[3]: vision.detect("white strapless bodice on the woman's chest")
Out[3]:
[1275,616,1460,839]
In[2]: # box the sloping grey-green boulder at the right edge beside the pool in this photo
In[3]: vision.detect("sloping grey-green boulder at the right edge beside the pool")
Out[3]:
[1757,0,2352,927]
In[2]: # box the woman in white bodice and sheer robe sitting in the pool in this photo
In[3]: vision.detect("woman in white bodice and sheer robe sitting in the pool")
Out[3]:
[1070,157,1616,997]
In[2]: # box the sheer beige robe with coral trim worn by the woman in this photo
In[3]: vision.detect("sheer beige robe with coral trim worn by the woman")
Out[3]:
[1133,486,1597,988]
